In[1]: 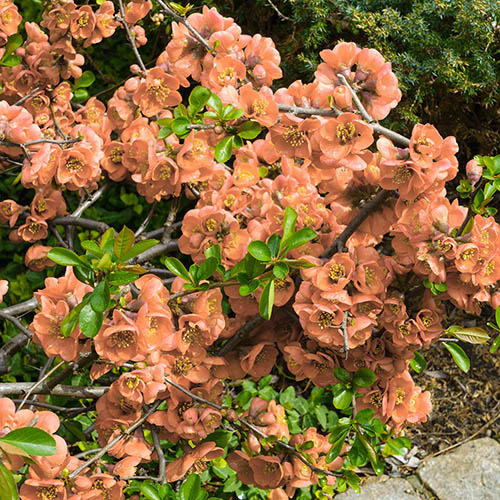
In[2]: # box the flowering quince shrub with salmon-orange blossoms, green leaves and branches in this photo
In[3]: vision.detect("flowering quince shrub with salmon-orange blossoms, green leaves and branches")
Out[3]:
[0,0,500,500]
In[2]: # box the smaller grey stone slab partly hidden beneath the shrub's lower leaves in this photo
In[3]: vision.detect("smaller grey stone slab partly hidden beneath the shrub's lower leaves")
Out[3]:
[335,476,422,500]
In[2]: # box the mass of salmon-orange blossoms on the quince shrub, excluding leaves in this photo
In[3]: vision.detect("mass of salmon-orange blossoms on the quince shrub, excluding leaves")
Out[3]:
[0,0,500,500]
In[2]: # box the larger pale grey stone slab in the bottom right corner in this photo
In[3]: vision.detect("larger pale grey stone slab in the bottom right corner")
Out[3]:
[418,438,500,500]
